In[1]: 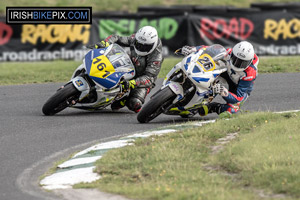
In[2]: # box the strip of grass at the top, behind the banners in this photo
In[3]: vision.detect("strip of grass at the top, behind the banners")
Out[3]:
[0,0,296,14]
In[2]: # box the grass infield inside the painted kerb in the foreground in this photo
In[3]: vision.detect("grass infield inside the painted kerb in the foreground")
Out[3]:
[75,113,300,200]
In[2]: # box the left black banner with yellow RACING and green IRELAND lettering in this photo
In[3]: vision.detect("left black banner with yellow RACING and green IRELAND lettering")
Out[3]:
[0,15,187,62]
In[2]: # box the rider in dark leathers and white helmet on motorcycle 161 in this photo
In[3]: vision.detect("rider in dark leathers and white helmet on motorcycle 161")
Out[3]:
[89,26,163,113]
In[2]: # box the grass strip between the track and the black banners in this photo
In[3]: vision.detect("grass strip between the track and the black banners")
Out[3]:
[0,56,300,85]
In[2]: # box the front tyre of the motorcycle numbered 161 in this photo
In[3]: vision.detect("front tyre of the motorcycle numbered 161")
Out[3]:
[42,83,79,115]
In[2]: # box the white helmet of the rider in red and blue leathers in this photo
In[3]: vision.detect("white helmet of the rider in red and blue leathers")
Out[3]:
[230,41,254,71]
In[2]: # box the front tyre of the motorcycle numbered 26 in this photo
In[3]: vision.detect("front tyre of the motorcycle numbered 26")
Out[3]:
[137,87,177,123]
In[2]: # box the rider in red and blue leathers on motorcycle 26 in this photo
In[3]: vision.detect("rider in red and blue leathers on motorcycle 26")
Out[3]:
[181,41,259,116]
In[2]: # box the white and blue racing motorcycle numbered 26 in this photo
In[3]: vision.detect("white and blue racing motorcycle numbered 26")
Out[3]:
[137,44,229,123]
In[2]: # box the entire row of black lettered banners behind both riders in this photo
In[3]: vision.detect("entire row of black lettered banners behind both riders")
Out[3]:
[0,11,300,62]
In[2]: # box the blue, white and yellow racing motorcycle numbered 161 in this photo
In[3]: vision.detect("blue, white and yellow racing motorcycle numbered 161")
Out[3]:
[42,44,135,115]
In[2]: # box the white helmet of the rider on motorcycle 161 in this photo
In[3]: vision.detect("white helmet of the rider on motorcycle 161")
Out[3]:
[133,26,158,56]
